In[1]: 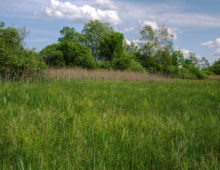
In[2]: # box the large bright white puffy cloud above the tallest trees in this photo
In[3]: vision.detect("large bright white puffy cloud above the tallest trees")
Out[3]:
[43,0,121,24]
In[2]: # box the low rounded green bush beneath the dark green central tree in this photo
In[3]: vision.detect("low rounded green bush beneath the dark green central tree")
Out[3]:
[113,56,146,72]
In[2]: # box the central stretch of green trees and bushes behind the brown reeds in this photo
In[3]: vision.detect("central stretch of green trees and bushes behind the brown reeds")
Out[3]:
[37,20,217,79]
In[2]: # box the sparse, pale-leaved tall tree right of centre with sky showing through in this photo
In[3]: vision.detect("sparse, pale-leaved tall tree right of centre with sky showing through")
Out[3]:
[137,25,174,72]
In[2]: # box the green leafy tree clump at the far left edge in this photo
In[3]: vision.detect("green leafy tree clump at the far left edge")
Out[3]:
[0,23,46,79]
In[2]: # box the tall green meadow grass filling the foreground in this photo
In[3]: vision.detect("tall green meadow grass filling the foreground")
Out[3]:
[0,77,220,170]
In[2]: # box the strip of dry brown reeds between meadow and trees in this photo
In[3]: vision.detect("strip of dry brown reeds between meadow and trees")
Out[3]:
[45,68,172,82]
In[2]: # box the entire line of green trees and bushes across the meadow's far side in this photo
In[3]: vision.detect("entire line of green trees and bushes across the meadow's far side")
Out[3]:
[0,20,220,79]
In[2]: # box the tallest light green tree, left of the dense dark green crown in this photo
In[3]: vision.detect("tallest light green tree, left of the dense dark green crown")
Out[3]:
[82,20,113,61]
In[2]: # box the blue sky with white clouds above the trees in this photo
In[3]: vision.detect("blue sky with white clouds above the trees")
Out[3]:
[0,0,220,63]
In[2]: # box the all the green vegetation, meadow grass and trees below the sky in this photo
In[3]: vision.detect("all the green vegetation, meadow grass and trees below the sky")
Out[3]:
[0,21,220,170]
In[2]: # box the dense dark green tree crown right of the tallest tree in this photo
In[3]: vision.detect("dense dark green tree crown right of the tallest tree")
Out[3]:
[100,32,124,61]
